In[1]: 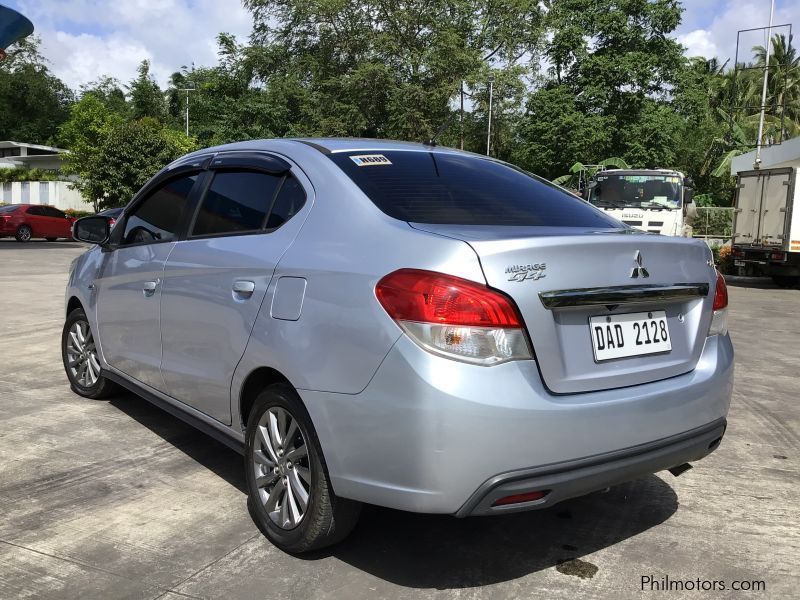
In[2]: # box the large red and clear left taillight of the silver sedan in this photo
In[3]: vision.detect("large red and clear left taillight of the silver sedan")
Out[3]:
[375,269,532,366]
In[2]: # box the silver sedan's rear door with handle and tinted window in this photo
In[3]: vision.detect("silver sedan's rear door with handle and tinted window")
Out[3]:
[161,155,306,424]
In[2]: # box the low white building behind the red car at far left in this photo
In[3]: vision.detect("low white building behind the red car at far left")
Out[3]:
[0,141,91,210]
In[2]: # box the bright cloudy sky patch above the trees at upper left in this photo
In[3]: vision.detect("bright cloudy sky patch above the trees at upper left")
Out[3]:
[16,0,252,88]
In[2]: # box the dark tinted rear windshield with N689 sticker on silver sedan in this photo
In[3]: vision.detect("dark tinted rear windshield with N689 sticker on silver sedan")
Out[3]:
[329,151,620,229]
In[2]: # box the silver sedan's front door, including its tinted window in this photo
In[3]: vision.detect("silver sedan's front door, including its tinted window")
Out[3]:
[95,170,200,391]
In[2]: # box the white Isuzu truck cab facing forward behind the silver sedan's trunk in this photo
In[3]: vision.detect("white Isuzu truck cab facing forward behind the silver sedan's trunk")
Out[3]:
[584,169,697,237]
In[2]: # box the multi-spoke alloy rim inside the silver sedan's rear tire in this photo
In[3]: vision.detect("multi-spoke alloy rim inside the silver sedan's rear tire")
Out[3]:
[252,406,311,529]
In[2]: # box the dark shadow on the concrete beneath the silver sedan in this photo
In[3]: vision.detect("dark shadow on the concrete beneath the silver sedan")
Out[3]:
[110,394,678,590]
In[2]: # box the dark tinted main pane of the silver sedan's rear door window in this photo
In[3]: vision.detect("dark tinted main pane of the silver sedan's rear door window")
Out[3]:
[192,171,282,236]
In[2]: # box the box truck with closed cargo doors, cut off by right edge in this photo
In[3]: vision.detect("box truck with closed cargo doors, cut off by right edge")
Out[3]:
[733,167,800,287]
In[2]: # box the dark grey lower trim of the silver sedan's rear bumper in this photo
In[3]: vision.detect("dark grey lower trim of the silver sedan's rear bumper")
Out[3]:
[456,419,727,517]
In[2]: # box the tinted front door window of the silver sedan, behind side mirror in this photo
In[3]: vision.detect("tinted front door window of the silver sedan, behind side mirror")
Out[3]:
[120,174,197,246]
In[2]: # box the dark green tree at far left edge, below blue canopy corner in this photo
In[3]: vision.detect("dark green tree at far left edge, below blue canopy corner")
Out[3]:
[0,37,74,144]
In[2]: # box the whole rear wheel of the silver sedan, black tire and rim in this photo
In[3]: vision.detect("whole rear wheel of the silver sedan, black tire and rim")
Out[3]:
[245,384,361,554]
